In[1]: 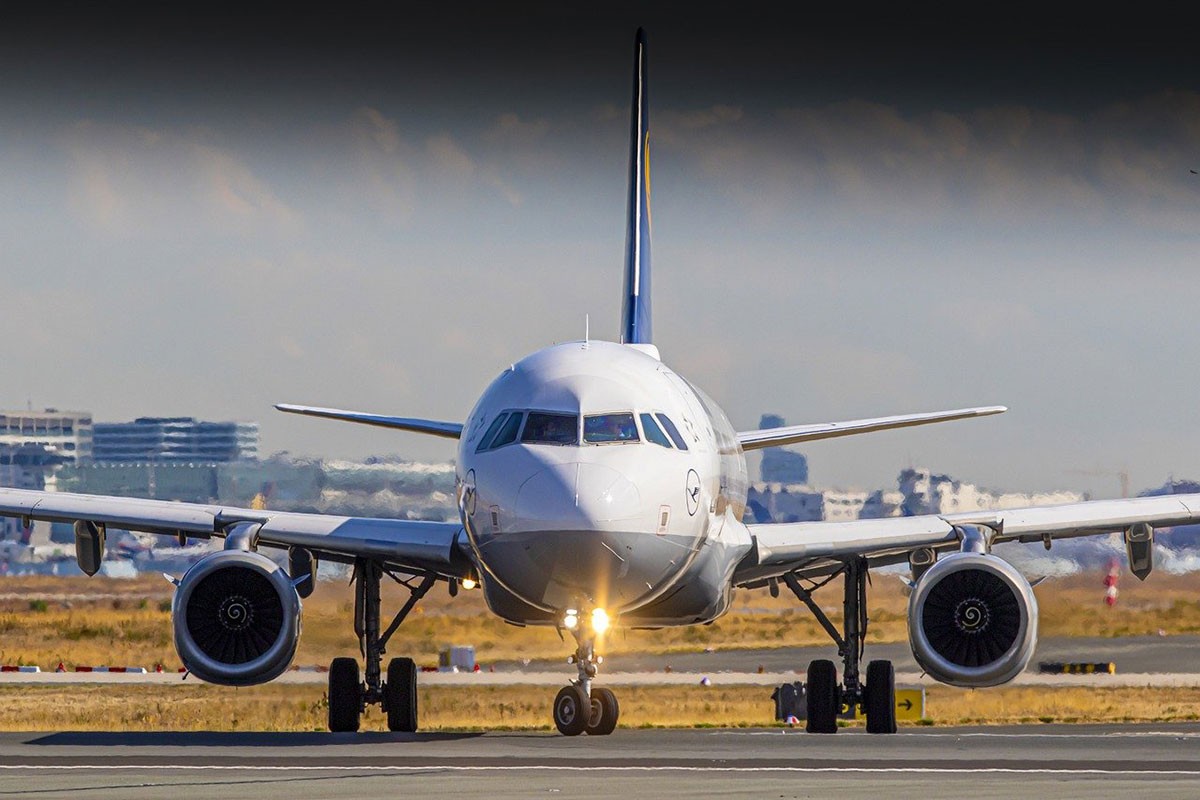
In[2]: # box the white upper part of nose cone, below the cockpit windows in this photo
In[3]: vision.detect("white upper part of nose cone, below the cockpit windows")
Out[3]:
[516,462,641,529]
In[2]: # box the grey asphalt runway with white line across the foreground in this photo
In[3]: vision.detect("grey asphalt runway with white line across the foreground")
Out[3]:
[0,723,1200,800]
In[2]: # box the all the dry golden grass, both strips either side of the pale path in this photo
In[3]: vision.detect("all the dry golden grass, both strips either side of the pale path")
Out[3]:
[0,573,1200,730]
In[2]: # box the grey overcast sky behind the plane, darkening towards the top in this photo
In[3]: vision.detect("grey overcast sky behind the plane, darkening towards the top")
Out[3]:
[0,4,1200,497]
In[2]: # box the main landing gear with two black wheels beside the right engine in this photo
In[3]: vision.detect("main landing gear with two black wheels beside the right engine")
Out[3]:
[784,558,896,733]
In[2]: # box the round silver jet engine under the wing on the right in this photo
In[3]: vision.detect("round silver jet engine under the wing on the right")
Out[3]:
[908,553,1038,687]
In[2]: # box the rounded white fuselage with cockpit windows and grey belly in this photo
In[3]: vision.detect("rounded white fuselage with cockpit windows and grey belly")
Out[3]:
[457,341,751,626]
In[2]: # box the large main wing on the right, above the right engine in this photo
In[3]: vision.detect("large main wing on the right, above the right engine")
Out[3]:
[734,494,1200,585]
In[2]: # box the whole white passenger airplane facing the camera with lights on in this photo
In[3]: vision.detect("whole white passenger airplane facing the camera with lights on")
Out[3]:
[0,29,1200,735]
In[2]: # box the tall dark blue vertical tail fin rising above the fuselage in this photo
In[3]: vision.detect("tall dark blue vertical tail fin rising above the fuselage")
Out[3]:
[620,28,654,344]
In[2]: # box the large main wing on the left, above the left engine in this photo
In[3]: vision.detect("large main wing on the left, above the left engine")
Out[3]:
[0,488,470,577]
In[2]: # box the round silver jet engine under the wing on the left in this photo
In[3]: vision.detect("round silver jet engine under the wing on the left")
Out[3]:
[170,551,300,686]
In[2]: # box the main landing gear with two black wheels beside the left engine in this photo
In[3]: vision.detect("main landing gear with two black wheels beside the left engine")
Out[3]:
[329,559,437,733]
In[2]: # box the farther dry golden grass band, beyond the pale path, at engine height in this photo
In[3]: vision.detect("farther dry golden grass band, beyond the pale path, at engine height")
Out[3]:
[0,573,1200,669]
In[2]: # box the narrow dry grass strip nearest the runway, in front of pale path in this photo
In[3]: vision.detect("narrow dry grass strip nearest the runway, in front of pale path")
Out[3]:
[0,682,1200,730]
